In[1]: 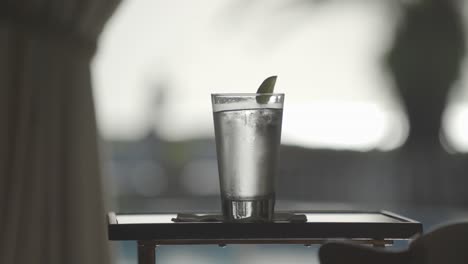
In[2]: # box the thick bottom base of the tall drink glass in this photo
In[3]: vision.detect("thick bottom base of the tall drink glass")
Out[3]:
[222,195,275,222]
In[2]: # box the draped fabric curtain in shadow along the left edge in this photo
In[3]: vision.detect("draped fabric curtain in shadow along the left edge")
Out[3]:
[0,0,119,264]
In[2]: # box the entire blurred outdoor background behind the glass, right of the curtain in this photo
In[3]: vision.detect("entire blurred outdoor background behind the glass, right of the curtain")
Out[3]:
[92,0,468,264]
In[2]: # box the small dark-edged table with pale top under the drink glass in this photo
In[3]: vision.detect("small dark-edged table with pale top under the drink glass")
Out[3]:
[108,211,423,264]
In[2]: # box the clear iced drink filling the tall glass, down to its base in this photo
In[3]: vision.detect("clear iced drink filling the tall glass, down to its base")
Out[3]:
[213,95,283,221]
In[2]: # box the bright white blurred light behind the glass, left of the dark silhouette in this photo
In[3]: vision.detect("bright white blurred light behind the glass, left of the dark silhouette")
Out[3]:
[93,0,414,150]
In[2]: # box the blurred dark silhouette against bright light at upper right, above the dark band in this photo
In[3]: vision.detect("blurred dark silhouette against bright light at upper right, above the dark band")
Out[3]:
[388,0,465,150]
